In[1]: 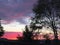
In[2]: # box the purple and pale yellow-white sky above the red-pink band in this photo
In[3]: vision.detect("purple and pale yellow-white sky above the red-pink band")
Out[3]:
[0,0,37,32]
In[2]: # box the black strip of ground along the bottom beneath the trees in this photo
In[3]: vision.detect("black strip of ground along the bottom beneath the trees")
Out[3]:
[0,39,60,45]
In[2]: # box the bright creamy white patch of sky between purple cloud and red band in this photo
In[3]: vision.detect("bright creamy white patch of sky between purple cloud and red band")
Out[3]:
[2,21,25,32]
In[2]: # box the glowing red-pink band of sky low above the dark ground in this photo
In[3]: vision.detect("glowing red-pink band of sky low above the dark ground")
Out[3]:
[1,32,23,40]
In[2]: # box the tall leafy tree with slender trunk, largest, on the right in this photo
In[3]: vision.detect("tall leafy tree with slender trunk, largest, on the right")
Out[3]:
[31,0,60,39]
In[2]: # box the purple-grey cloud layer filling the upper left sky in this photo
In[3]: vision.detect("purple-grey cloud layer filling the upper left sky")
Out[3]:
[0,0,37,24]
